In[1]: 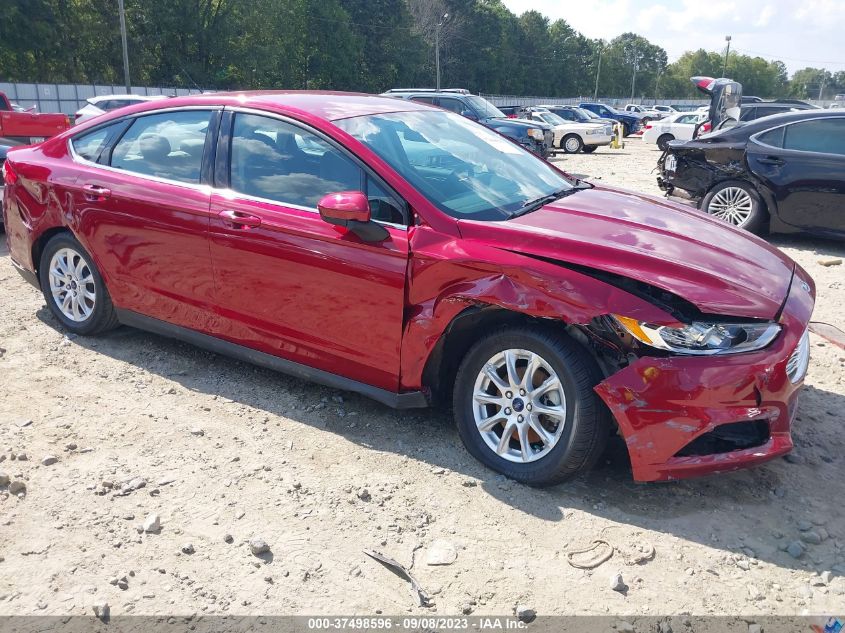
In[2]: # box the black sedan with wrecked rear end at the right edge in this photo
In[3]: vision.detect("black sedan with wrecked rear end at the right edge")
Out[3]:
[658,110,845,238]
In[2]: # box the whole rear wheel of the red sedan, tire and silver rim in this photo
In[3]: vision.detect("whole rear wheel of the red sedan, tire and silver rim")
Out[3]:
[38,233,119,335]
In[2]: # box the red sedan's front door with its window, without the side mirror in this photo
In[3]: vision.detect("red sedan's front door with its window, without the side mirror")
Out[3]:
[211,112,408,391]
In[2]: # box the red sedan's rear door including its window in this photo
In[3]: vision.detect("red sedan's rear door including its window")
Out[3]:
[72,108,219,331]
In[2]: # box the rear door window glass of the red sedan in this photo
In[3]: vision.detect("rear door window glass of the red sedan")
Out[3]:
[111,110,211,184]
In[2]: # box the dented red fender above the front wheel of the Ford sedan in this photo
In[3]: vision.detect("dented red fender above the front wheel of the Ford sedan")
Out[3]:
[400,226,677,390]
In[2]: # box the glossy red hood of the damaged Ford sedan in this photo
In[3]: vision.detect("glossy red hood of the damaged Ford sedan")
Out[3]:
[459,187,795,319]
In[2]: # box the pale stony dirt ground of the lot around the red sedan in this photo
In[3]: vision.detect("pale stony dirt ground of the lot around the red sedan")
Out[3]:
[0,139,845,616]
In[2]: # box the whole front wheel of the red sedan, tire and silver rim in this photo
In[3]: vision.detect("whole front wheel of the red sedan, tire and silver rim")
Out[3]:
[453,327,610,486]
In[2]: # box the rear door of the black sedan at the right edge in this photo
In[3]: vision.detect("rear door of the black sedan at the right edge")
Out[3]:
[747,116,845,233]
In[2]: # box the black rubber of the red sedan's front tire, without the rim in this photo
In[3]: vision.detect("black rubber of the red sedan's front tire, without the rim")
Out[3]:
[453,329,607,486]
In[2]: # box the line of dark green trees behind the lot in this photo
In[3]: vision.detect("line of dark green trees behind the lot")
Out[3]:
[0,0,845,99]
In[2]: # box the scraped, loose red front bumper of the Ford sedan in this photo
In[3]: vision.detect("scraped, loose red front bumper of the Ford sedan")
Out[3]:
[596,267,814,481]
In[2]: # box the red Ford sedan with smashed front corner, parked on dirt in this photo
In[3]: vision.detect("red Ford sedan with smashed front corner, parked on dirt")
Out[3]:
[4,92,814,485]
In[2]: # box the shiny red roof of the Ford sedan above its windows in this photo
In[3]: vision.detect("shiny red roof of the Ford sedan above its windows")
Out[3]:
[76,90,432,121]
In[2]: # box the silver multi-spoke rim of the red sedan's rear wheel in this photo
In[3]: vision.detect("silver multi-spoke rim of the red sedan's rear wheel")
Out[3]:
[50,248,97,323]
